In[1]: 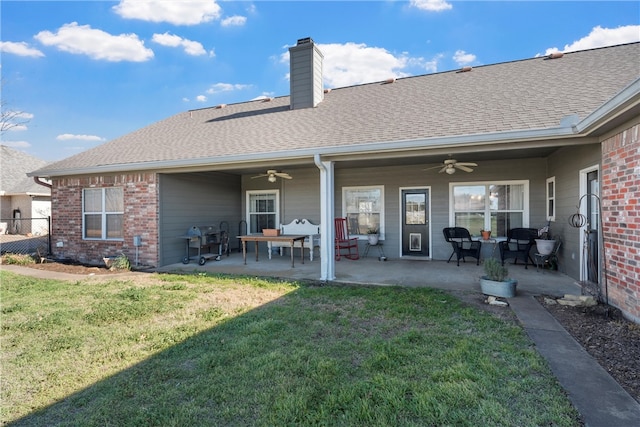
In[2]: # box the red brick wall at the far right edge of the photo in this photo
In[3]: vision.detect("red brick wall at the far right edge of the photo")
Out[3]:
[602,125,640,322]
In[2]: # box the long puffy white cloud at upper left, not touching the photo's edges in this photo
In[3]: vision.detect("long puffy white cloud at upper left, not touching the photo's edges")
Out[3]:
[35,22,153,62]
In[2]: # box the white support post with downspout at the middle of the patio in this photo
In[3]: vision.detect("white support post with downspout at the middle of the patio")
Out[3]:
[313,154,336,281]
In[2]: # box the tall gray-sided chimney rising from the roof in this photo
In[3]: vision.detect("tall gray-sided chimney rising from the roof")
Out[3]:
[289,37,324,110]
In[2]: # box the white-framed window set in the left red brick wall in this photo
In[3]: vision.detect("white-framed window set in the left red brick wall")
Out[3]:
[82,187,124,240]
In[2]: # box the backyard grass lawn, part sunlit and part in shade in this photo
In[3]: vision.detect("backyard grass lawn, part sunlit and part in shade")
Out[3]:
[0,271,580,426]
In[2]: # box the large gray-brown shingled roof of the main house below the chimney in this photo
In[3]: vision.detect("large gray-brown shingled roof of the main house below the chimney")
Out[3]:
[31,43,640,176]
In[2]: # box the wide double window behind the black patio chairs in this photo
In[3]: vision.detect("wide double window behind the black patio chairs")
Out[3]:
[450,181,529,237]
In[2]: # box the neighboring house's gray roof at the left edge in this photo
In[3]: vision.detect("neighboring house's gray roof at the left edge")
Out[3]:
[0,145,51,196]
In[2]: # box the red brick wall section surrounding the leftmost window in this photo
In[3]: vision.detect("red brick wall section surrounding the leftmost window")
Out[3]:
[51,173,159,267]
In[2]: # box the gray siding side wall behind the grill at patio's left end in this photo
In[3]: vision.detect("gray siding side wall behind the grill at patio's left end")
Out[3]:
[159,174,243,265]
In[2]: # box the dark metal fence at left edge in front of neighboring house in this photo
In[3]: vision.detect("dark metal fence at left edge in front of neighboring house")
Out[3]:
[0,217,51,256]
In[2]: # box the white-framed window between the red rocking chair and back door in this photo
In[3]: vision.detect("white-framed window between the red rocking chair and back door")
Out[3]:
[342,186,384,236]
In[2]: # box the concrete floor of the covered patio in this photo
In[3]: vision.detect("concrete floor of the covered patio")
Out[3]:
[158,251,581,296]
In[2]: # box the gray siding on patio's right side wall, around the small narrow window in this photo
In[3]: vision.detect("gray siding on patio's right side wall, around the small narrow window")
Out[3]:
[548,144,602,279]
